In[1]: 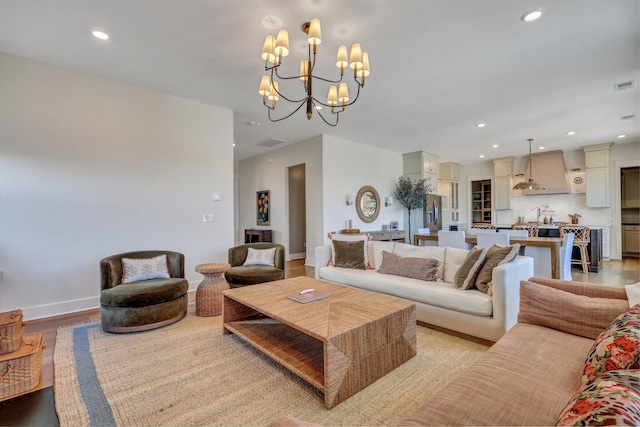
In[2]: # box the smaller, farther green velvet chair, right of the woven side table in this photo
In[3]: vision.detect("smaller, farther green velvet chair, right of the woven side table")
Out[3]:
[224,242,285,288]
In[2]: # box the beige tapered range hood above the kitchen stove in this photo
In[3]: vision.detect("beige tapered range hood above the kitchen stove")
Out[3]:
[522,150,571,196]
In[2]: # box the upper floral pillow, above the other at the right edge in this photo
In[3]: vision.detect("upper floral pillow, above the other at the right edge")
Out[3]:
[582,304,640,384]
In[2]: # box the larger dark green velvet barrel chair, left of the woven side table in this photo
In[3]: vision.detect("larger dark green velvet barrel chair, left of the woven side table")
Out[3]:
[100,251,189,333]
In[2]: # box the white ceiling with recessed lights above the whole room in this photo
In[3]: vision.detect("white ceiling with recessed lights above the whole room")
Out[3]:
[0,0,640,164]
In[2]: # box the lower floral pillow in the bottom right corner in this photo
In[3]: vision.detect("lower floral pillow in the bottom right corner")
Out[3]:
[556,369,640,426]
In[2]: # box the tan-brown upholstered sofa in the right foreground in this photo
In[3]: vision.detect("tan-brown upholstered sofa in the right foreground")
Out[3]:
[402,277,629,426]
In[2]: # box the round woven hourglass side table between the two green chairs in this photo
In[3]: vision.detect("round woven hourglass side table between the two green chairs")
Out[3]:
[196,262,231,317]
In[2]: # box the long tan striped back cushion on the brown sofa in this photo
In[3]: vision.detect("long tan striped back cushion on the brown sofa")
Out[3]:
[518,280,626,339]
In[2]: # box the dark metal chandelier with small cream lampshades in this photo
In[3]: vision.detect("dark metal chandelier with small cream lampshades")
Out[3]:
[258,18,371,126]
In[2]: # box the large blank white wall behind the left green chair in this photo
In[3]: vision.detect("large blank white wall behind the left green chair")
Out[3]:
[0,53,233,319]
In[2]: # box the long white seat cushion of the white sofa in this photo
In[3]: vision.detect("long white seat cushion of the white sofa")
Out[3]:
[318,267,493,317]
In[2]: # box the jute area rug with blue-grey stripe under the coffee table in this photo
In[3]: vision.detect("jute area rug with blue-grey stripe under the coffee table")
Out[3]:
[54,307,487,426]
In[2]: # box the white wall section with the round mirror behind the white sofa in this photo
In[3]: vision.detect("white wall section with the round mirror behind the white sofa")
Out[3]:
[322,135,402,244]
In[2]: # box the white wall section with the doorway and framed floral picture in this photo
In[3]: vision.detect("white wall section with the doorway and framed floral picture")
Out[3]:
[235,136,323,265]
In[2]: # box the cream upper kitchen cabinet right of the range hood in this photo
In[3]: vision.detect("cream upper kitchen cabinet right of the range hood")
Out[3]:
[582,142,613,208]
